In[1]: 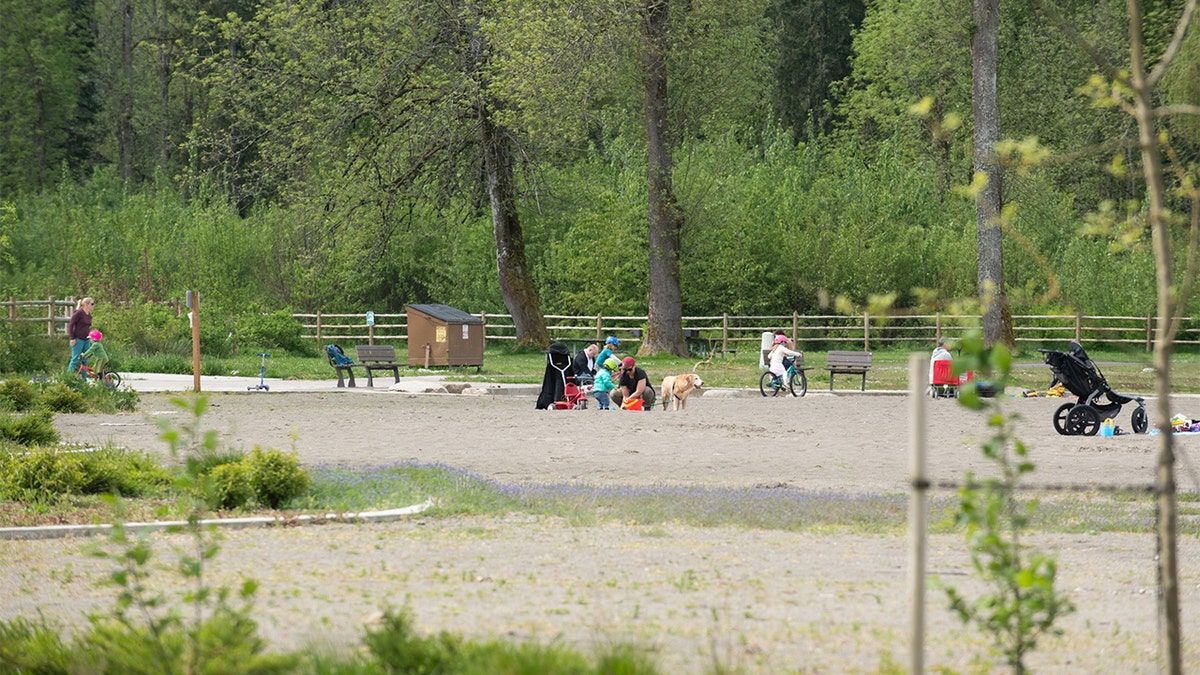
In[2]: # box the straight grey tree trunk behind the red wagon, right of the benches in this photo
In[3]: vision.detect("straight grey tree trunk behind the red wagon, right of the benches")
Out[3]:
[971,0,1014,346]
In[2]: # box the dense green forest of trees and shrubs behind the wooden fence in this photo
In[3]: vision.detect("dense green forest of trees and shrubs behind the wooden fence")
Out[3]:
[0,0,1200,348]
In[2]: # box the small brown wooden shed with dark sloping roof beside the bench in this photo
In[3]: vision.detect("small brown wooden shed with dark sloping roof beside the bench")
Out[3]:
[404,305,484,368]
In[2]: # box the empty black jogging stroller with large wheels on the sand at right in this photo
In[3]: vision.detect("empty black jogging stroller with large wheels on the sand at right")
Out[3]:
[1038,340,1150,436]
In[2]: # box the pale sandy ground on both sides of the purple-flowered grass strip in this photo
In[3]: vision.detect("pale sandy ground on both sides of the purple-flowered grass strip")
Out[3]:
[0,393,1200,673]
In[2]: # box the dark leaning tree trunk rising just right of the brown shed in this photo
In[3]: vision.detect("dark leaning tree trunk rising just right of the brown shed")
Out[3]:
[479,111,550,350]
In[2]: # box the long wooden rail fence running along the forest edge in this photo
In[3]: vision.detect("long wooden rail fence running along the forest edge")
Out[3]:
[0,297,1200,353]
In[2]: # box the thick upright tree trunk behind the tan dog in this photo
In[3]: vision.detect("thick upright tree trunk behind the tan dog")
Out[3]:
[637,0,688,357]
